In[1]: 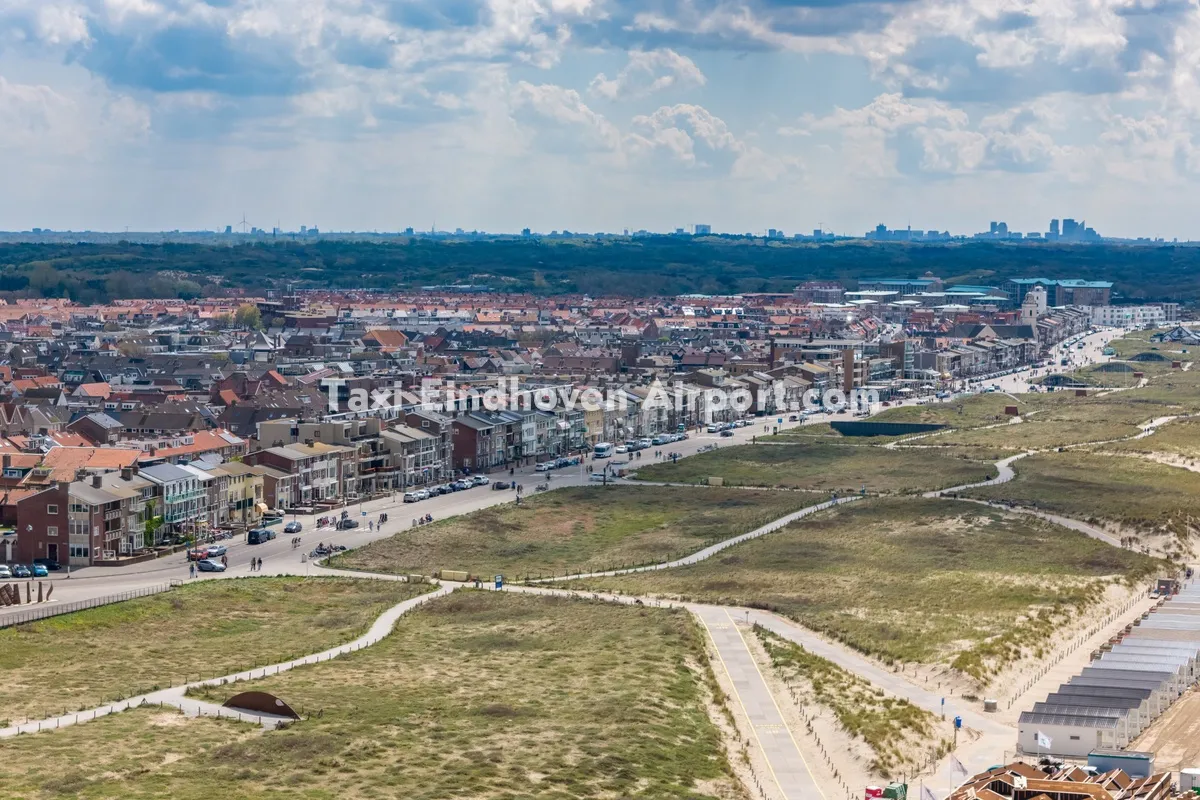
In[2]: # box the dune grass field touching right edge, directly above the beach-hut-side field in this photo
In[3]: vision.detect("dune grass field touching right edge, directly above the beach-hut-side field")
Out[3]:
[967,450,1200,537]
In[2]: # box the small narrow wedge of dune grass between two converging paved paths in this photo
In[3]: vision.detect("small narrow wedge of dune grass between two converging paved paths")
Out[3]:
[754,625,950,777]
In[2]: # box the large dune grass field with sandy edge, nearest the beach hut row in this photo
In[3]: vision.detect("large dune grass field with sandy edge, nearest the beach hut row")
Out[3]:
[570,498,1158,679]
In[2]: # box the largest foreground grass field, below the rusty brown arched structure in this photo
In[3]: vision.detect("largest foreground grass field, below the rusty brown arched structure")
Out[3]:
[0,591,746,800]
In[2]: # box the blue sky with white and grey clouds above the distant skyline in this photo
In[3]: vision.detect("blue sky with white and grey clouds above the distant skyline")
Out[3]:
[0,0,1200,239]
